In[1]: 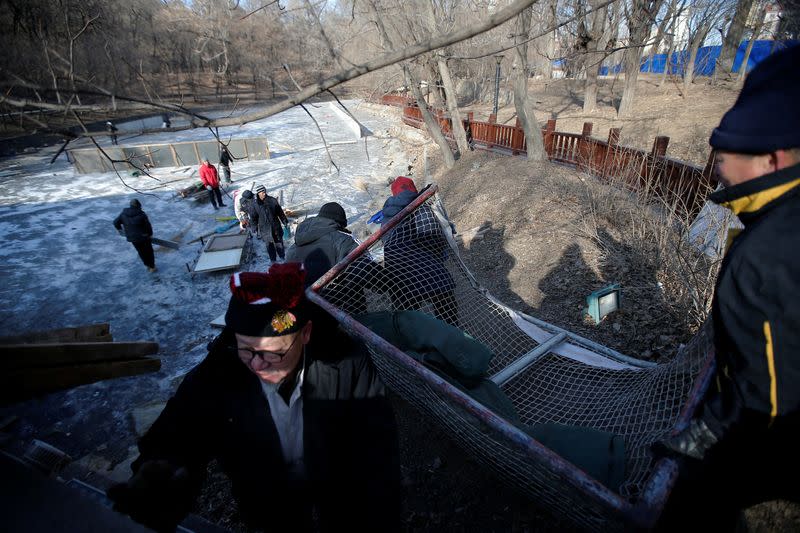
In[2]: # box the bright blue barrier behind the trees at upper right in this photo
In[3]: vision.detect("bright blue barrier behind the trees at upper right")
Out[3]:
[600,40,800,76]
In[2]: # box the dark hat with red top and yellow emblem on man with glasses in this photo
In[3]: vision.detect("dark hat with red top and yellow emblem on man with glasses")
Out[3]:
[225,263,310,337]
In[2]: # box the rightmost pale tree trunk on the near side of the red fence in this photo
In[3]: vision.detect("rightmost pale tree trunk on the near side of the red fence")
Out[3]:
[514,7,546,161]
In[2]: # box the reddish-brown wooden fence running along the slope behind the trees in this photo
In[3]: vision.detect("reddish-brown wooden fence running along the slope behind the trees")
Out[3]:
[382,95,716,211]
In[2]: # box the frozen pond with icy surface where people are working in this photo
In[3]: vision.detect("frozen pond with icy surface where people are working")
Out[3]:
[0,102,408,475]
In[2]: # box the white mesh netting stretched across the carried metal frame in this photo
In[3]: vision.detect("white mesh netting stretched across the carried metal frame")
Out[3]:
[312,190,710,529]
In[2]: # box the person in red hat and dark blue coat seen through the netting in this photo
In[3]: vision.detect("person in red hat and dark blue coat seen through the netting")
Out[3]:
[381,176,459,327]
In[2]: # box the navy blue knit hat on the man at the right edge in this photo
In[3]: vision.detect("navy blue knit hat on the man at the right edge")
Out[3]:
[708,46,800,154]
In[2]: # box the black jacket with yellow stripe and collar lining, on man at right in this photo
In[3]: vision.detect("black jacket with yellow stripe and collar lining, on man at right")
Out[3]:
[701,165,800,454]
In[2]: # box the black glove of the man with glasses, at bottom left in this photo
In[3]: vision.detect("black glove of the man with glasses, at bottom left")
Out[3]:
[107,461,192,531]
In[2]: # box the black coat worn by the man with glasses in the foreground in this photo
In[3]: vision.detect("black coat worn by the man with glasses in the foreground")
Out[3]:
[133,330,400,531]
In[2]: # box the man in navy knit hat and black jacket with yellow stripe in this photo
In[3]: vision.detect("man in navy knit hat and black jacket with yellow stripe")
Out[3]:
[661,47,800,530]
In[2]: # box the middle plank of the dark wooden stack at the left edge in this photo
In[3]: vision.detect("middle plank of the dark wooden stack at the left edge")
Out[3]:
[0,342,158,370]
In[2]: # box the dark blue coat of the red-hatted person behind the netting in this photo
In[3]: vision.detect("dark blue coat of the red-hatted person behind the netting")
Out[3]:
[383,191,455,299]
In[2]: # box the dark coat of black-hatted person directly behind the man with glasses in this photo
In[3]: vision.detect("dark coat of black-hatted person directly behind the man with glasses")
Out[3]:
[286,217,358,284]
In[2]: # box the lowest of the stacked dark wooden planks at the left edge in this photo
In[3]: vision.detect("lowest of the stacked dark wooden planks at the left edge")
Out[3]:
[0,357,161,403]
